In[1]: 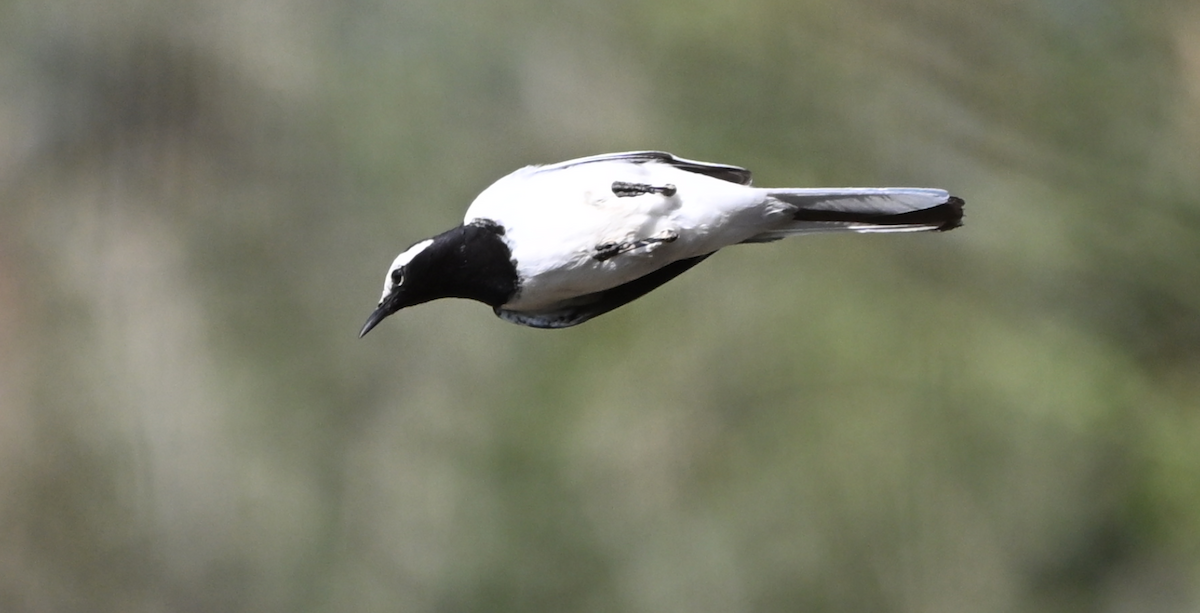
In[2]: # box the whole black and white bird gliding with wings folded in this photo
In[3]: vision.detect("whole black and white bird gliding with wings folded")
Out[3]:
[359,151,962,337]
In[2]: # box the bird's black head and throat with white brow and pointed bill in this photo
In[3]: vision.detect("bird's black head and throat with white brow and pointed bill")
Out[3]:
[359,220,517,338]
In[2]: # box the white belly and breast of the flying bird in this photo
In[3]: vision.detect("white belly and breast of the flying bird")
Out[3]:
[466,160,785,309]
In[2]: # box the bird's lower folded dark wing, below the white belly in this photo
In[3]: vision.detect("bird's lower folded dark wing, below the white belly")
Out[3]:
[496,253,712,327]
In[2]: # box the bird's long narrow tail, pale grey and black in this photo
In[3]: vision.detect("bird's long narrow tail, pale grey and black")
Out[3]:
[745,187,964,242]
